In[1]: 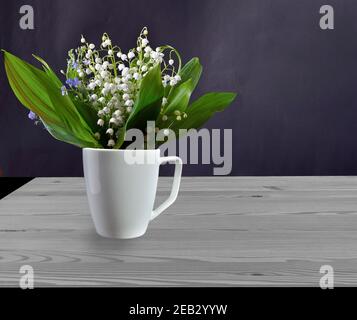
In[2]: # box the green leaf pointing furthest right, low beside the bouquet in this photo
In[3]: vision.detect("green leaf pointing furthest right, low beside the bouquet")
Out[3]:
[171,92,236,134]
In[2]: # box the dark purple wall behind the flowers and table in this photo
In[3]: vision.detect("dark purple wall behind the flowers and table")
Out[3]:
[0,0,357,176]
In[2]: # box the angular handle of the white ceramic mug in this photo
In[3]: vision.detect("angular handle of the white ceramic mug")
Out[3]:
[150,156,182,220]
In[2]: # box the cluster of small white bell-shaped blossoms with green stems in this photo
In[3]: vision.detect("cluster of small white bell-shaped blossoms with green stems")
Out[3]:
[61,28,185,147]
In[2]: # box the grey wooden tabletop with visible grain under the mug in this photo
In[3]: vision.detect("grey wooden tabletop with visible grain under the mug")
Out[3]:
[0,177,357,286]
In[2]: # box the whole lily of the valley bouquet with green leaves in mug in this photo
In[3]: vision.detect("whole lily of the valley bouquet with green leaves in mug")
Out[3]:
[4,28,236,149]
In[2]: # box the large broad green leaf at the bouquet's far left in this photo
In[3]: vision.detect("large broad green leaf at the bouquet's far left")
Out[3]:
[4,51,99,147]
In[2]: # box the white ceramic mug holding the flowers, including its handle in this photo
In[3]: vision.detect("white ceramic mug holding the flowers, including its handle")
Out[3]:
[83,148,182,239]
